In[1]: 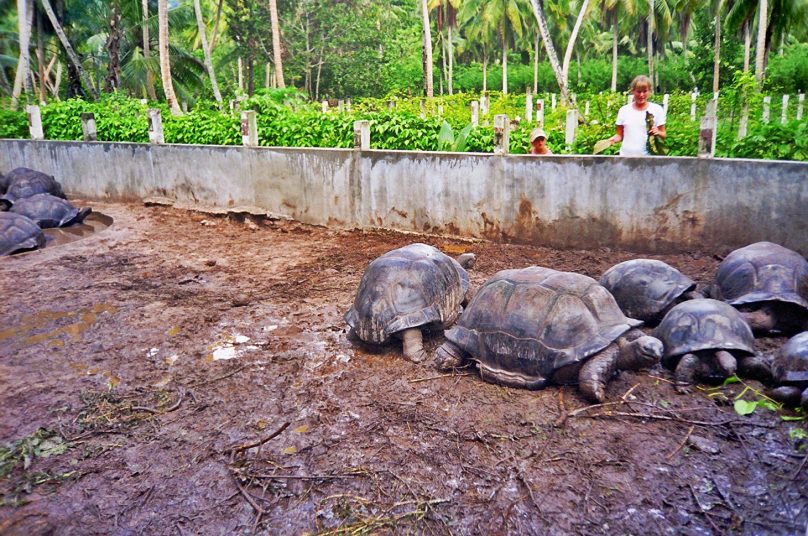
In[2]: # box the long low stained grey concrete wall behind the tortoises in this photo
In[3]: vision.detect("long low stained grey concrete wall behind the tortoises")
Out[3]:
[0,140,808,254]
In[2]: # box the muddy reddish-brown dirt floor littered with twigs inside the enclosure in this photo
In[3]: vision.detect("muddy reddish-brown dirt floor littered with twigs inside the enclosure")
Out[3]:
[0,201,808,536]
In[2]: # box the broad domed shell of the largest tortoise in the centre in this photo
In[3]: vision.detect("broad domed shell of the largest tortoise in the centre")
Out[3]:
[446,266,642,380]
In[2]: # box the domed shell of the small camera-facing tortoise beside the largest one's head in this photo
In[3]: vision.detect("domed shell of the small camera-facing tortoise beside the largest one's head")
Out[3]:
[652,299,755,368]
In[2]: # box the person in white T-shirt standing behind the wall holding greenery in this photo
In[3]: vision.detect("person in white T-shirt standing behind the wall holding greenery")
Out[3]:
[608,75,666,156]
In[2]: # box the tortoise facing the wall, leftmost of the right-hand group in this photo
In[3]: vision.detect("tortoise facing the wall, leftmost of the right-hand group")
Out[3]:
[345,244,475,363]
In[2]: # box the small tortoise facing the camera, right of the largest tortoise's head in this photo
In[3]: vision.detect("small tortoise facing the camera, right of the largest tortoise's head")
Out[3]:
[653,299,770,391]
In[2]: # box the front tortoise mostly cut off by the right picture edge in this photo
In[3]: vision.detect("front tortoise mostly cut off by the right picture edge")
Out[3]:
[769,331,808,409]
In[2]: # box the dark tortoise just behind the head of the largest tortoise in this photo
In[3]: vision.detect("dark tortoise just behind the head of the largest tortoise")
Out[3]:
[600,259,704,324]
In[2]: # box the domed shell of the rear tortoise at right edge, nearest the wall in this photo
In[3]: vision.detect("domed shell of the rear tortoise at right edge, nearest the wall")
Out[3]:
[716,242,808,309]
